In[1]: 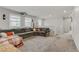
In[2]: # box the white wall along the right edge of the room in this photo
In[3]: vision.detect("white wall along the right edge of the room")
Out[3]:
[72,7,79,50]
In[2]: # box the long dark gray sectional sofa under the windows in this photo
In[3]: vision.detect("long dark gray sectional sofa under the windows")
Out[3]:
[0,28,50,38]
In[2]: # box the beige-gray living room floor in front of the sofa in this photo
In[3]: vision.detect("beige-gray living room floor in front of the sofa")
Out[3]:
[19,36,78,52]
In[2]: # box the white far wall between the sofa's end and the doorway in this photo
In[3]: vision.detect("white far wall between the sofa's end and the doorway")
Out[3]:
[45,17,63,34]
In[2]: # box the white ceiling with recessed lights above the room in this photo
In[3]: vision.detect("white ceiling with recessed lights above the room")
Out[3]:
[4,6,74,18]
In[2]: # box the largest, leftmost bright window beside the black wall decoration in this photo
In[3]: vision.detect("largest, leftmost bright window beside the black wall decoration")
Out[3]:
[10,15,21,27]
